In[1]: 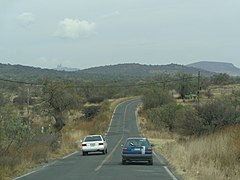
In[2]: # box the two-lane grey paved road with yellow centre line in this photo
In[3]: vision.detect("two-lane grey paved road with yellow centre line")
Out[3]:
[16,100,176,180]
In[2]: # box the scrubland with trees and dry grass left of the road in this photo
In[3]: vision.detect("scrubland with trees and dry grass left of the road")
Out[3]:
[0,80,134,179]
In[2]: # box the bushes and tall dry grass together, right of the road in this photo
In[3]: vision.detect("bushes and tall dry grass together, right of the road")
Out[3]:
[140,82,240,180]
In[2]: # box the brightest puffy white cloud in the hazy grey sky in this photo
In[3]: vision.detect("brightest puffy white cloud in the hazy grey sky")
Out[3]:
[55,18,96,39]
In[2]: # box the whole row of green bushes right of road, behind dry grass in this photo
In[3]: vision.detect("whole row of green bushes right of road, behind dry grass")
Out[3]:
[146,95,240,136]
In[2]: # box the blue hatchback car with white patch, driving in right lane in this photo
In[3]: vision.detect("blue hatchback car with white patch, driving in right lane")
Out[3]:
[122,137,153,165]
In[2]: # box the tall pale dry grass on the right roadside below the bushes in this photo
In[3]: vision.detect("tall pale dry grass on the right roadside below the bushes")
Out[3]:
[141,118,240,180]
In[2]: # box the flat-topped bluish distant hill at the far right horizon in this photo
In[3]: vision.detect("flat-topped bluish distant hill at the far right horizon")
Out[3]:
[187,61,240,76]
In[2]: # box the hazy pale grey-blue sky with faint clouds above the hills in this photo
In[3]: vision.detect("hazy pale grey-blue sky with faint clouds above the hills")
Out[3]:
[0,0,240,69]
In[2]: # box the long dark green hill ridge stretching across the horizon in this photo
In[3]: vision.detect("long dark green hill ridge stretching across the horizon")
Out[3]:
[0,63,212,82]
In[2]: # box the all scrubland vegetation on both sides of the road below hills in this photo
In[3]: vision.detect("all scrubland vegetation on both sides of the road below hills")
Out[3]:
[0,71,240,179]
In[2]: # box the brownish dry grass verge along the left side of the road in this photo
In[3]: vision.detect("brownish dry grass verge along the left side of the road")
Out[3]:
[0,98,133,180]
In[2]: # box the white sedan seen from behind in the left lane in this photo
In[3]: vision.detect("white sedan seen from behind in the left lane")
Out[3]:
[82,135,107,156]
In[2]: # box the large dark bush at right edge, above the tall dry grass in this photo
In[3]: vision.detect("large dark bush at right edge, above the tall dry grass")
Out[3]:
[175,99,240,135]
